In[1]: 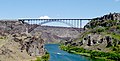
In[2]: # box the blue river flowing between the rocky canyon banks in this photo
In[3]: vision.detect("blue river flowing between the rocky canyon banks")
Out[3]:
[45,44,98,61]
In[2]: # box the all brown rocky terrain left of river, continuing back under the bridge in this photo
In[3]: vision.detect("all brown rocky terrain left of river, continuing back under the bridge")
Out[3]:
[0,20,79,61]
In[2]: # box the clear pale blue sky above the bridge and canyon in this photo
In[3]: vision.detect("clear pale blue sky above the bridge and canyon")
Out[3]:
[0,0,120,26]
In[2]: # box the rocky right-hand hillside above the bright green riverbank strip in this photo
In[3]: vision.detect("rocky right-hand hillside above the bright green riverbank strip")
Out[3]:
[66,13,120,50]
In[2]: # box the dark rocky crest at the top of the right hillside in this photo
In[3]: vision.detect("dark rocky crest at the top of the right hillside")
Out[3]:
[84,13,120,29]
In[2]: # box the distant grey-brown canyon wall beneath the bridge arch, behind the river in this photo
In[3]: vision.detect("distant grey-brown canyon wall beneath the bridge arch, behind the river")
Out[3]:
[31,26,79,43]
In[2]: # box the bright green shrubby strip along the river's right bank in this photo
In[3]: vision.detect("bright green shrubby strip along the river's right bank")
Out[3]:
[60,45,120,61]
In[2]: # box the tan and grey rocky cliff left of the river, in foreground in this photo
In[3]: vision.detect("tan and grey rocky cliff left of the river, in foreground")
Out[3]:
[0,20,45,61]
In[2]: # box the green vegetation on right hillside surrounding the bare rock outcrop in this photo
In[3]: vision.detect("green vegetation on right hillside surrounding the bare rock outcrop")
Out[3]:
[60,20,120,61]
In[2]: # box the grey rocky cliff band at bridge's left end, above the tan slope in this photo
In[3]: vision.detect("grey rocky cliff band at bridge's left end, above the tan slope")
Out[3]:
[0,20,26,34]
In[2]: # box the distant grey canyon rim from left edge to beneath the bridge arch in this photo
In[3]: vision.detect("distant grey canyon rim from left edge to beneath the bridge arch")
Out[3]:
[0,20,80,43]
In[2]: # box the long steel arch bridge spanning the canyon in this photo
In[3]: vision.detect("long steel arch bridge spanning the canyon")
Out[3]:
[18,19,92,32]
